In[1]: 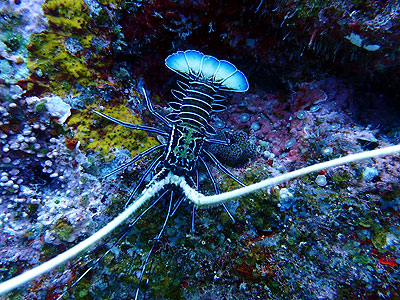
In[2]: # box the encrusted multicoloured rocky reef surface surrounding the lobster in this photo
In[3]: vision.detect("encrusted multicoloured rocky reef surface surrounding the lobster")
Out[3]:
[0,0,400,300]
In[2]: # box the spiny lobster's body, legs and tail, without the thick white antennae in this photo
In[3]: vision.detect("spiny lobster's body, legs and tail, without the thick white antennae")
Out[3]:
[84,50,249,299]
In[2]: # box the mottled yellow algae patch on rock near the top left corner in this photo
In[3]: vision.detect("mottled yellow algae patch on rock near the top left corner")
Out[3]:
[27,0,113,95]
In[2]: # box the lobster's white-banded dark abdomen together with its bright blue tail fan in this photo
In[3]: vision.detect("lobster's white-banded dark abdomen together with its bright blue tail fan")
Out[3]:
[165,50,249,135]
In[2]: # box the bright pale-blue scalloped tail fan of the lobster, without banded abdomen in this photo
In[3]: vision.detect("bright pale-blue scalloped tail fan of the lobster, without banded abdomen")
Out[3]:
[165,50,249,92]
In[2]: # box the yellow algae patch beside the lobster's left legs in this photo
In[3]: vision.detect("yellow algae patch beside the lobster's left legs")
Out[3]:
[68,103,159,159]
